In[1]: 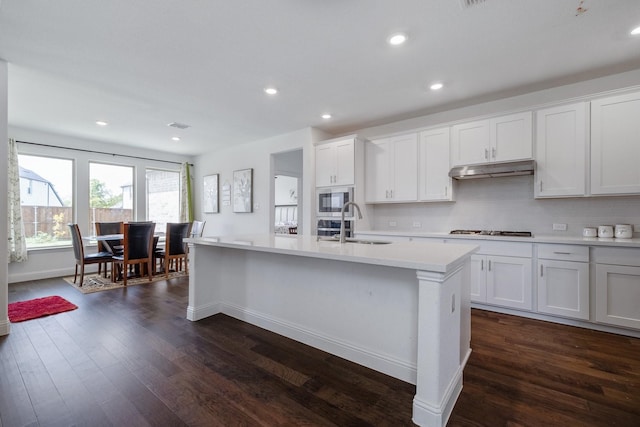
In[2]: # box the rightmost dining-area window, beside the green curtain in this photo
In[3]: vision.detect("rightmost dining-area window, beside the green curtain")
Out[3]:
[147,169,180,231]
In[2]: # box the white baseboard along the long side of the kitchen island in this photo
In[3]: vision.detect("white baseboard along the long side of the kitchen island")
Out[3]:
[220,303,417,384]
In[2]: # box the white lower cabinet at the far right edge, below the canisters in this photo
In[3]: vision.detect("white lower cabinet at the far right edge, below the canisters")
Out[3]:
[594,248,640,329]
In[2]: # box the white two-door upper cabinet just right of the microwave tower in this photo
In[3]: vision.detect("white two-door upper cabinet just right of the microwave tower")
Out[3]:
[365,133,418,203]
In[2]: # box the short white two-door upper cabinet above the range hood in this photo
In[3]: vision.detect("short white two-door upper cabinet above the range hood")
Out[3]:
[451,111,533,166]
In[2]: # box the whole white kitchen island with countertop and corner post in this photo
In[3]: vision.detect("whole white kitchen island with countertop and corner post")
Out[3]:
[185,235,476,426]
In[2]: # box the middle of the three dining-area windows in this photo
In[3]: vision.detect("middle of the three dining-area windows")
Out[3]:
[89,162,134,232]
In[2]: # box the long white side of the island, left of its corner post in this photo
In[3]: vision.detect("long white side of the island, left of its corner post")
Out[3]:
[190,245,418,384]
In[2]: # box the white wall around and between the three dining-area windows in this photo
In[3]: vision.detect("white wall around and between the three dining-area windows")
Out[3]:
[3,126,192,283]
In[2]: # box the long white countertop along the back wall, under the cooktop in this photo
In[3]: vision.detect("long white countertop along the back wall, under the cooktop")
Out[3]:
[356,230,640,248]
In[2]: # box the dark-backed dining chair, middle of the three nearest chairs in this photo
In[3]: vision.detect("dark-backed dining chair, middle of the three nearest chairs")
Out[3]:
[111,222,156,286]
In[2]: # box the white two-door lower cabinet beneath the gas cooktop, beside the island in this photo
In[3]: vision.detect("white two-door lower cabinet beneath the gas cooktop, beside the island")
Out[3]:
[465,241,533,310]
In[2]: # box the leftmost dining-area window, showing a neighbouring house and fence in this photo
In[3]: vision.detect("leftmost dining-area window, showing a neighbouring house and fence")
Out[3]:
[18,154,73,249]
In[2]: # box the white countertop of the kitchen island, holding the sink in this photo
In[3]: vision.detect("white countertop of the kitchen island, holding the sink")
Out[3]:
[184,235,478,273]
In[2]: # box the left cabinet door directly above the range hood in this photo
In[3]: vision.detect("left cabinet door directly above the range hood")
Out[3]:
[451,120,491,166]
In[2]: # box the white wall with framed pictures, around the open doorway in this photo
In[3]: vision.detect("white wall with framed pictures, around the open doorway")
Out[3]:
[194,128,327,236]
